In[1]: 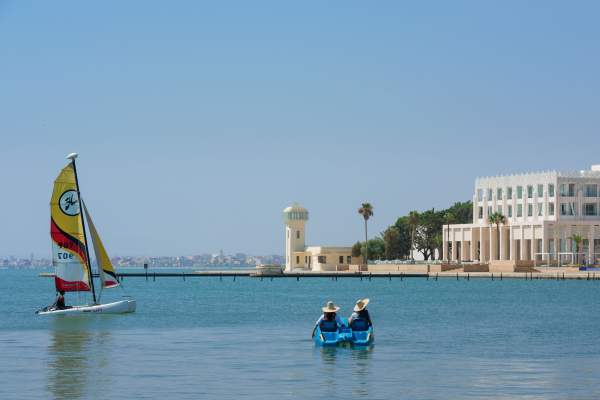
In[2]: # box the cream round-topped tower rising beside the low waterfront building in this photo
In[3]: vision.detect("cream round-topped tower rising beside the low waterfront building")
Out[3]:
[283,203,308,272]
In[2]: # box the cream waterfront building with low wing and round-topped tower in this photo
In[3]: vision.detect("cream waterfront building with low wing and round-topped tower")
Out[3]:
[283,204,352,272]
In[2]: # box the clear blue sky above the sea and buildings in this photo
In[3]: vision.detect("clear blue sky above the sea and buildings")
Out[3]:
[0,0,600,256]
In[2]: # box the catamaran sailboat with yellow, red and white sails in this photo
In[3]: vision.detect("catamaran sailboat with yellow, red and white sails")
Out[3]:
[37,153,136,315]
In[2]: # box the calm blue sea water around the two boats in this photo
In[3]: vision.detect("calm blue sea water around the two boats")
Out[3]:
[0,270,600,400]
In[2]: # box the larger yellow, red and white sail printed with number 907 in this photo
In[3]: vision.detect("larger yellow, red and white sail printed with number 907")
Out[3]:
[50,163,91,292]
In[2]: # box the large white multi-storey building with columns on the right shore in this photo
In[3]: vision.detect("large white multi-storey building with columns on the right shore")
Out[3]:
[443,165,600,267]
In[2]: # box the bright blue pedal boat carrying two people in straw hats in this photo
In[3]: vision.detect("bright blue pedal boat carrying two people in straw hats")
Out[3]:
[313,319,375,347]
